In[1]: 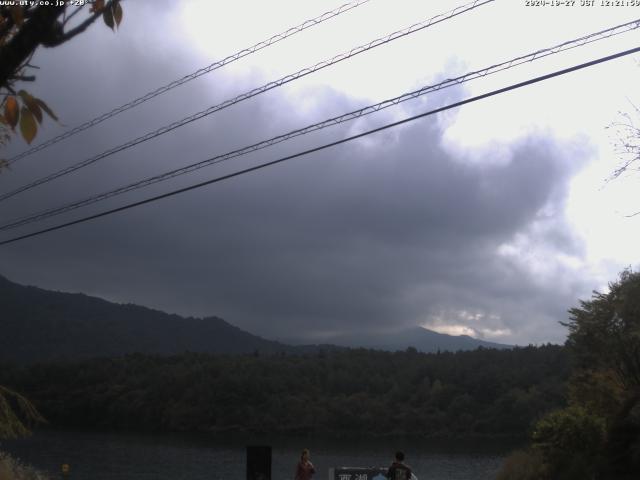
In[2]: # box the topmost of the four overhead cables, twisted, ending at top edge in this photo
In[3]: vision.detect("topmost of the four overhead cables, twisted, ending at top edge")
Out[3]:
[7,0,369,165]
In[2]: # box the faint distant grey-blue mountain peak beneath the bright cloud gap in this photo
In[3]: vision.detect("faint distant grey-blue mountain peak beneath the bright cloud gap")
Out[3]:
[284,327,512,353]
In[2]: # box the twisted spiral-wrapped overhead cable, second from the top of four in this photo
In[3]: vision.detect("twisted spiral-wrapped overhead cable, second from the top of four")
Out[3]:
[0,0,495,201]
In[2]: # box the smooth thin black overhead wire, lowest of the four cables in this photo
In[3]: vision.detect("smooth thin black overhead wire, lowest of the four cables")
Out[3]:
[0,47,640,245]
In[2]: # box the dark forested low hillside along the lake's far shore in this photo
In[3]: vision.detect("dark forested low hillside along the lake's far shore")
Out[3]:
[0,345,568,436]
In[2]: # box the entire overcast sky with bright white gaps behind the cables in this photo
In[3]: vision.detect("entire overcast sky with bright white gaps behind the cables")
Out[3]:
[0,0,640,344]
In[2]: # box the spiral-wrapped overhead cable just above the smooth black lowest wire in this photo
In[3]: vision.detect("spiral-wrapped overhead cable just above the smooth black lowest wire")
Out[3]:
[0,19,640,231]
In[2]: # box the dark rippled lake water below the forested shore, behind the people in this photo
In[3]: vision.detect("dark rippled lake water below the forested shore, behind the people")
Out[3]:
[0,432,517,480]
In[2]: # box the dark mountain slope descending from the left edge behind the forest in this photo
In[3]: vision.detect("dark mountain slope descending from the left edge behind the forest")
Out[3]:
[0,276,296,362]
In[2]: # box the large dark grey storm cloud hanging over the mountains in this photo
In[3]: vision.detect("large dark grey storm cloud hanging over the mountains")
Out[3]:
[0,1,590,343]
